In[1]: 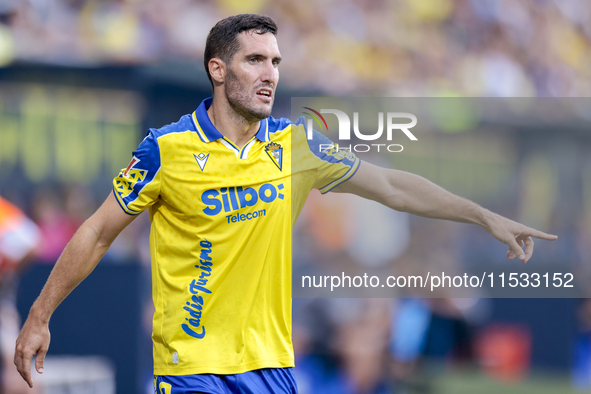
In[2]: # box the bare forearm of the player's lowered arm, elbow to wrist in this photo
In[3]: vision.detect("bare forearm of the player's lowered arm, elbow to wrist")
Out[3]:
[29,221,109,323]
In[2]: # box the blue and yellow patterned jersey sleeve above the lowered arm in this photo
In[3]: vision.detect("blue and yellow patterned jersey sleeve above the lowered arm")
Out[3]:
[113,131,161,215]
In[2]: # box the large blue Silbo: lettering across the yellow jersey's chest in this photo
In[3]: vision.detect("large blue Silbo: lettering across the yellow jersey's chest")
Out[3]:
[201,183,285,216]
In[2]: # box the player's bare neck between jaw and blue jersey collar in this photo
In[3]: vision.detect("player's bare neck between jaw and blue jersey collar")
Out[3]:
[207,95,260,148]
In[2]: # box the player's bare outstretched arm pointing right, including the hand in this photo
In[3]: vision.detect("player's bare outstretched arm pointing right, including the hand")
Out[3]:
[333,162,558,263]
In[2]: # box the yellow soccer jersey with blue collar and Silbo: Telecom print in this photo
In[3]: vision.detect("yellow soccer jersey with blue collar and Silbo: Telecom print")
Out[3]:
[113,98,359,375]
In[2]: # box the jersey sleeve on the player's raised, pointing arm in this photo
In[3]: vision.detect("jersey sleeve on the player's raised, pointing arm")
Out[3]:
[294,117,360,194]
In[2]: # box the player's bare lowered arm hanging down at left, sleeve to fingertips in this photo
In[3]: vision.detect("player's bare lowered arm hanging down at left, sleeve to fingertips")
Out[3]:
[14,194,135,387]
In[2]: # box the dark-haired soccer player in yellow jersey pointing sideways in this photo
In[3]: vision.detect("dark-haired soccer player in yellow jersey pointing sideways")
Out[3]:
[15,15,556,394]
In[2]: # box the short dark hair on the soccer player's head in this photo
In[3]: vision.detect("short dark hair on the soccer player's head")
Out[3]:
[203,14,277,86]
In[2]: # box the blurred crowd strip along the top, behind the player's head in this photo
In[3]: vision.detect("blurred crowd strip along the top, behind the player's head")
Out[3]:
[0,0,591,97]
